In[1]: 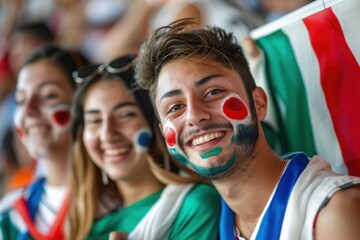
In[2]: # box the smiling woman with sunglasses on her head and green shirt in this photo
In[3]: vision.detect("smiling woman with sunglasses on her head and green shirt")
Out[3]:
[67,54,220,239]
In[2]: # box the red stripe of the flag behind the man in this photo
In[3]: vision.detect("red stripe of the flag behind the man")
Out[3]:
[304,8,360,176]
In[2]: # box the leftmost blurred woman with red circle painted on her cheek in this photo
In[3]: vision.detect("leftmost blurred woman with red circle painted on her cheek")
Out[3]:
[0,46,88,239]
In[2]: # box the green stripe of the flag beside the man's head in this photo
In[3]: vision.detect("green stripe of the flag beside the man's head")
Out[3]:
[257,30,316,156]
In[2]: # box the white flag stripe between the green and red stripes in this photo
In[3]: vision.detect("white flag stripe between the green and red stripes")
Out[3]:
[283,21,348,174]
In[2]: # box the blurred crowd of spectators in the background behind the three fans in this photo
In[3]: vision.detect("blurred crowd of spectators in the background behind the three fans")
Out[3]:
[0,0,310,202]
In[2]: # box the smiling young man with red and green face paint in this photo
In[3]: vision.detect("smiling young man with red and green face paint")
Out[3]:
[136,20,360,240]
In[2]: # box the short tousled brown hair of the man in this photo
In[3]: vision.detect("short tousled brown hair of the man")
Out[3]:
[135,19,256,116]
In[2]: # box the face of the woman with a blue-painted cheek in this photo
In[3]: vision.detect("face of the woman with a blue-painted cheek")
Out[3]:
[83,79,151,181]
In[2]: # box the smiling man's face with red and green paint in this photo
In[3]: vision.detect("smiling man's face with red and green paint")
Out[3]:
[155,57,258,179]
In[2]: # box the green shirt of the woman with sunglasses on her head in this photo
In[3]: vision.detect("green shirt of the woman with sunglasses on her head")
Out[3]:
[87,184,220,240]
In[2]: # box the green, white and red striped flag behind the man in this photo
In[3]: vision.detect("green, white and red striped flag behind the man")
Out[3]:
[251,0,360,176]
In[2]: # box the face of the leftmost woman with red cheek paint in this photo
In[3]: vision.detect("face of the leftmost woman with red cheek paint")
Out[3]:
[14,59,74,158]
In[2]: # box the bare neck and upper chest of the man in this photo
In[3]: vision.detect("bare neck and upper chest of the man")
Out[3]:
[213,152,286,239]
